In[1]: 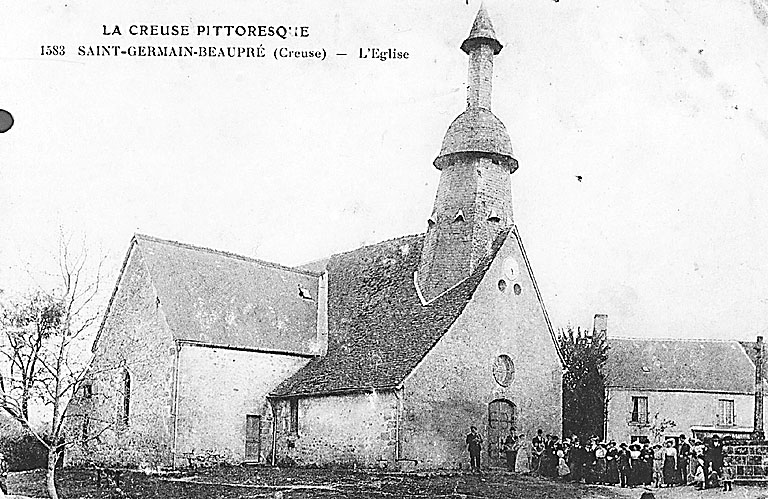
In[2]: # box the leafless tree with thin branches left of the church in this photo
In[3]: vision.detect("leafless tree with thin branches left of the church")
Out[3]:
[0,235,103,499]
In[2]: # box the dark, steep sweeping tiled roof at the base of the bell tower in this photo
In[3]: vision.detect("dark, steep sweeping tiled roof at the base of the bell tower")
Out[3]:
[272,230,509,397]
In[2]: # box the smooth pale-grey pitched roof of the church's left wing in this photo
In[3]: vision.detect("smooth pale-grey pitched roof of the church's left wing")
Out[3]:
[97,234,321,355]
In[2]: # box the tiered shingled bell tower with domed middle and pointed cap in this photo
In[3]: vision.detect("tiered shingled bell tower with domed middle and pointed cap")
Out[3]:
[417,6,517,301]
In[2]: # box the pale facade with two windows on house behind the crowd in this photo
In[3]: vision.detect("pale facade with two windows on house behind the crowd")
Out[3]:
[607,389,755,443]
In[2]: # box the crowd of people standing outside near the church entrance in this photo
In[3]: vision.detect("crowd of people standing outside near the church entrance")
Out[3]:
[467,427,733,490]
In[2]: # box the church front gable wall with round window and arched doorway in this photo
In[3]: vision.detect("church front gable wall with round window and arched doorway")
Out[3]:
[401,232,562,468]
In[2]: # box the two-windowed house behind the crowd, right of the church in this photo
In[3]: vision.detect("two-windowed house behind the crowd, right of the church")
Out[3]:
[605,336,755,442]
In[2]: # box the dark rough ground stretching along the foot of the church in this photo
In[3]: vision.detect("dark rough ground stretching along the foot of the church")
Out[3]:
[8,467,640,499]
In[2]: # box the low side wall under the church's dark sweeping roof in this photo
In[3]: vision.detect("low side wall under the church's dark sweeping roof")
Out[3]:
[278,392,398,468]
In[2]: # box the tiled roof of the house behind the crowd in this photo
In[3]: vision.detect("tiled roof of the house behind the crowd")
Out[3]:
[606,338,755,394]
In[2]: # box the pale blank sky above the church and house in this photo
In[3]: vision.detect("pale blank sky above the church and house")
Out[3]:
[0,0,768,339]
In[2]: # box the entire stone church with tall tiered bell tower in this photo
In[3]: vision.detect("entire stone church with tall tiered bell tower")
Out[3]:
[69,7,563,469]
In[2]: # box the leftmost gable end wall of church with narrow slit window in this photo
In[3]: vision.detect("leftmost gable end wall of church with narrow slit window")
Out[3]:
[67,246,175,465]
